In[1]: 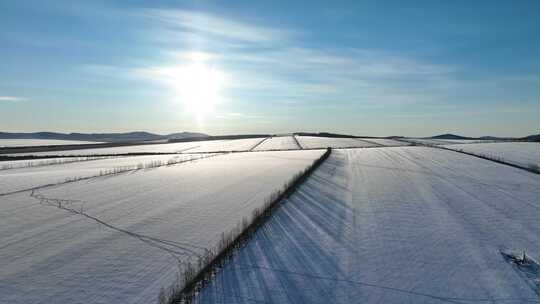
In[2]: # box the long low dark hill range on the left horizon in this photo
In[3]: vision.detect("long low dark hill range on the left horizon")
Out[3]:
[0,131,208,142]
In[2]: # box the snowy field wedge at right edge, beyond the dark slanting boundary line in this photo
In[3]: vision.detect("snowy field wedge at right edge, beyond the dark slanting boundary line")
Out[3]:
[447,142,540,167]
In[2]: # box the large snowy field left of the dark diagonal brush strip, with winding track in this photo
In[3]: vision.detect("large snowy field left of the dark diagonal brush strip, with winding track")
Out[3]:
[0,150,323,304]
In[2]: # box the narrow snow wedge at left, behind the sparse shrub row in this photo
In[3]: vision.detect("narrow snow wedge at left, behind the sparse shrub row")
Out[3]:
[0,154,215,194]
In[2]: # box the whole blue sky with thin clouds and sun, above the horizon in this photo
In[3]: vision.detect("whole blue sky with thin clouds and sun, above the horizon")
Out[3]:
[0,0,540,136]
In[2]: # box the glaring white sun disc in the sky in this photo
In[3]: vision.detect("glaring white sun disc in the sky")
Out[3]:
[172,61,225,118]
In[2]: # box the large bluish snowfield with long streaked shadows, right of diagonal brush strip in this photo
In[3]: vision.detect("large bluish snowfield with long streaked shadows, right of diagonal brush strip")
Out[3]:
[197,144,540,303]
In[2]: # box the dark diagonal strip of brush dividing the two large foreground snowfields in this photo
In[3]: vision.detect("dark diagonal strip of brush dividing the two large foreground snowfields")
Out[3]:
[162,148,332,304]
